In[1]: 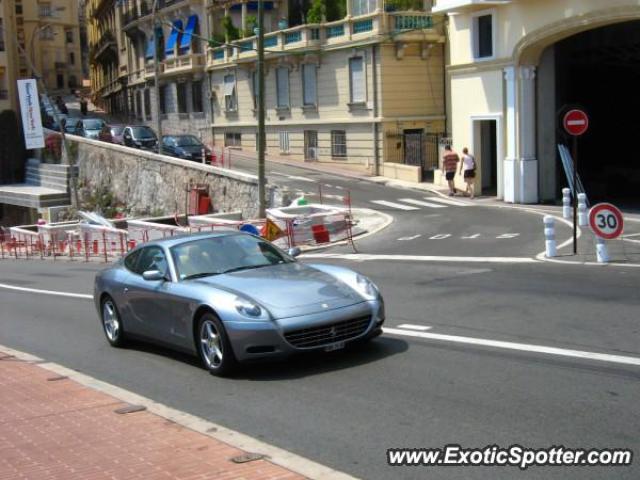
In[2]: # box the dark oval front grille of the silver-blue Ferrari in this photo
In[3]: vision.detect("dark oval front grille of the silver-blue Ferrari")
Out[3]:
[284,316,371,348]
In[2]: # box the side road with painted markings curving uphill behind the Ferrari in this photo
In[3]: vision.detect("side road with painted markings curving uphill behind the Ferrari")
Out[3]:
[232,152,572,257]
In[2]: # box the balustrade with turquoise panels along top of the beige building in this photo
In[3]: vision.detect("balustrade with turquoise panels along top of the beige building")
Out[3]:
[207,12,443,68]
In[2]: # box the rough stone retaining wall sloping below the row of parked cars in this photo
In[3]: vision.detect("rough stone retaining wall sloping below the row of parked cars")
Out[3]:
[68,136,275,218]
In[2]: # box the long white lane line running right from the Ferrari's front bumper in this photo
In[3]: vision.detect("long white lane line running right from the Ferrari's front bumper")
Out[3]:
[383,327,640,366]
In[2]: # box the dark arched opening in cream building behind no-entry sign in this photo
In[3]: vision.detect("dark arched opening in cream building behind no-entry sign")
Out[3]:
[537,20,640,207]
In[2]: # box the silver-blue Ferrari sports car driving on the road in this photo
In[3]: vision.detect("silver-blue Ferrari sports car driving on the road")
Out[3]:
[94,231,385,375]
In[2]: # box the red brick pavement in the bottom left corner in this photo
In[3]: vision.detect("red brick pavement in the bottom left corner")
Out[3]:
[0,353,303,480]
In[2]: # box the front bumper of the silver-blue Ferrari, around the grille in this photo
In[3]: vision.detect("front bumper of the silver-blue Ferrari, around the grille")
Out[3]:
[224,299,385,362]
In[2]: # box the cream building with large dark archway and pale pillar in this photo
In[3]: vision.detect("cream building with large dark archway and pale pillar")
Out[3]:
[434,0,640,204]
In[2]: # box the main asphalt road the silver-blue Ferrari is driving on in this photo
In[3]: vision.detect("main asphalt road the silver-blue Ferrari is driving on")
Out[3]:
[0,260,640,479]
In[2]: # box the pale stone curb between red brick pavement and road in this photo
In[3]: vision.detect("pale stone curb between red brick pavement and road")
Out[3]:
[0,344,357,480]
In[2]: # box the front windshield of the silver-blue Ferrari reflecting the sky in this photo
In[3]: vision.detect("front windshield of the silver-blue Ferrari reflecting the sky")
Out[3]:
[171,234,295,280]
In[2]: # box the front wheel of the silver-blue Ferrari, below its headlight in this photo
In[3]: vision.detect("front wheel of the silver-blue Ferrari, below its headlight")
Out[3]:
[197,313,236,376]
